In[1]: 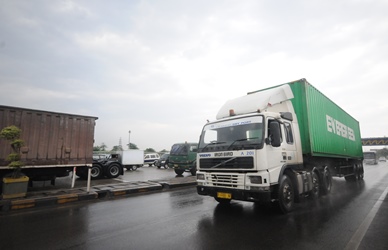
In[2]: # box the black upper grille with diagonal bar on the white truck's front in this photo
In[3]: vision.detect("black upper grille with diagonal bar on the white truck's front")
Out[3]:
[199,157,253,169]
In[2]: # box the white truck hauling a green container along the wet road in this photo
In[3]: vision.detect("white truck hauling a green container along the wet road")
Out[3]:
[197,79,364,213]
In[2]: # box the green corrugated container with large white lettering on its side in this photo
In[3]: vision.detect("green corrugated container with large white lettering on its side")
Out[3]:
[288,79,363,158]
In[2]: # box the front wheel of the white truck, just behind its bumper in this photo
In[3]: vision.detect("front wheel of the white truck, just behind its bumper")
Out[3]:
[278,175,295,213]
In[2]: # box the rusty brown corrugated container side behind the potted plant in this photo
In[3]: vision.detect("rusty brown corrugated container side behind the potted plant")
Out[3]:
[0,106,98,167]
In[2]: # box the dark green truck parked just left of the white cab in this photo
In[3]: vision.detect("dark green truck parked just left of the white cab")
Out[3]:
[169,142,198,175]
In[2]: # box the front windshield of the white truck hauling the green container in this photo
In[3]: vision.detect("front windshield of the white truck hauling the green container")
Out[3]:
[199,116,264,152]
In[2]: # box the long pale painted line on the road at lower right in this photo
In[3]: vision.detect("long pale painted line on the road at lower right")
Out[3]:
[345,187,388,250]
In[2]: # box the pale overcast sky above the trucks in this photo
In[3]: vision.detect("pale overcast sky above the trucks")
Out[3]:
[0,0,388,151]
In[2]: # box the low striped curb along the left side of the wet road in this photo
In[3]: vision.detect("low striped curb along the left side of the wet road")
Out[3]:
[0,178,196,212]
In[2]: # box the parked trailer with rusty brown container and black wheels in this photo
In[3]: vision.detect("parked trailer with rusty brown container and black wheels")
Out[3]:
[0,105,123,185]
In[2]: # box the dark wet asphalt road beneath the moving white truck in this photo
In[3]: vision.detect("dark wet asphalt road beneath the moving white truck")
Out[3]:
[0,162,388,249]
